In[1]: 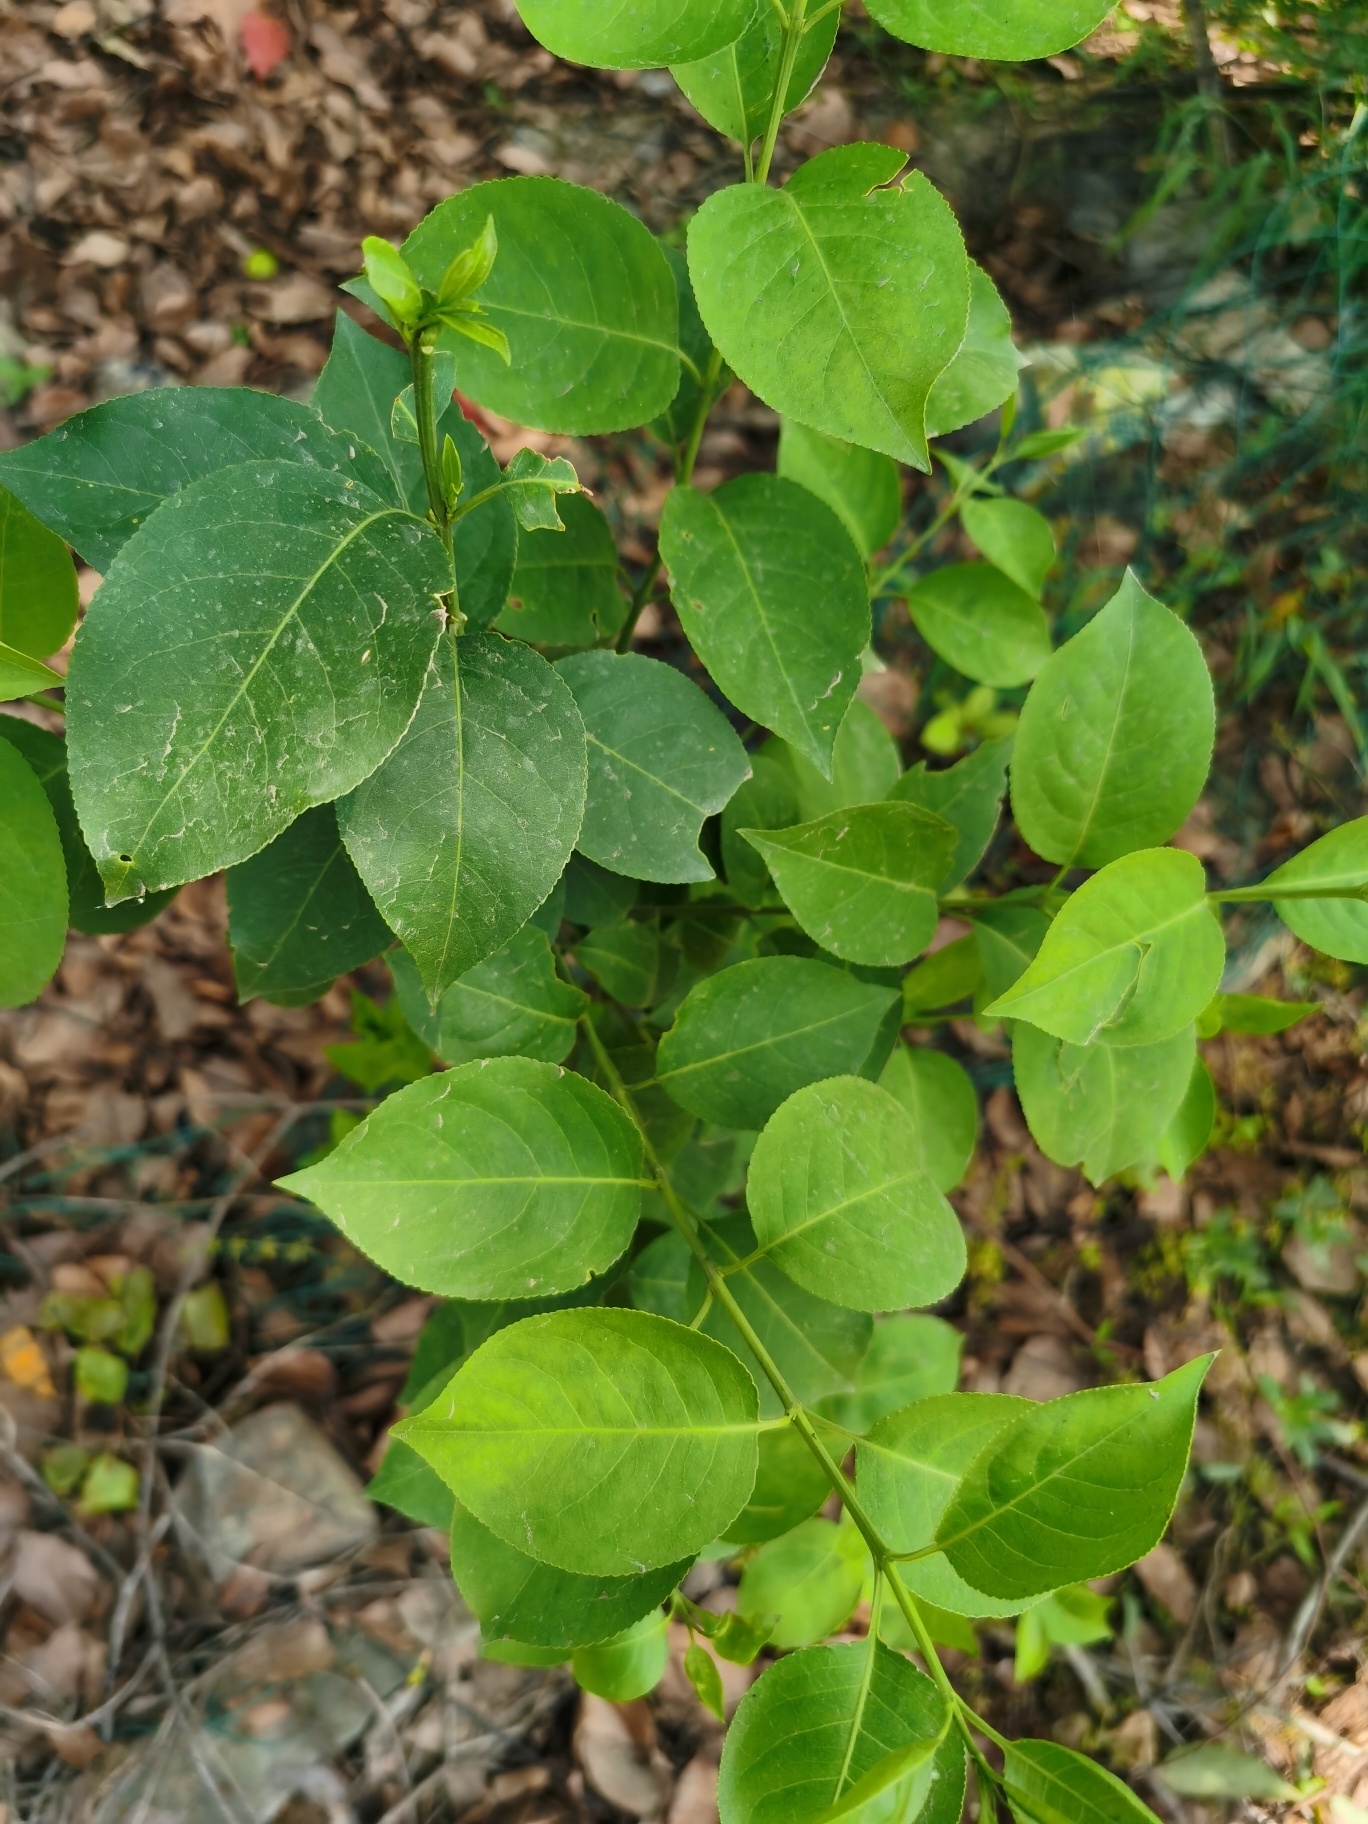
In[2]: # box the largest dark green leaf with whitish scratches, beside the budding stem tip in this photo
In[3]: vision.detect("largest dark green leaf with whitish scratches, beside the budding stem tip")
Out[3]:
[66,463,451,903]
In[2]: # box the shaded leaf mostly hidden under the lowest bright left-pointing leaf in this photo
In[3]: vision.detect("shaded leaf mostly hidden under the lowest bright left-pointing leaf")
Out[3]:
[450,1495,693,1649]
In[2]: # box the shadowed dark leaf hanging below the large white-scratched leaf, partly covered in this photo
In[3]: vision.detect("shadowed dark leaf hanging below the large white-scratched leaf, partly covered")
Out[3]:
[228,804,394,1007]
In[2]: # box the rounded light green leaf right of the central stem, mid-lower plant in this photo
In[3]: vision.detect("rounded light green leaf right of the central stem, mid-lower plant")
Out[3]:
[746,1076,965,1311]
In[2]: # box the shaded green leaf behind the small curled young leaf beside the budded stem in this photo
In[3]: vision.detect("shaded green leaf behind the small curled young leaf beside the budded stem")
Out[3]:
[496,494,627,646]
